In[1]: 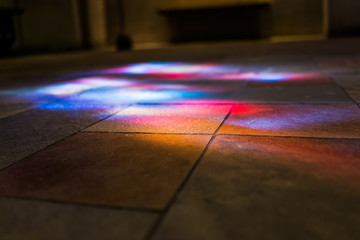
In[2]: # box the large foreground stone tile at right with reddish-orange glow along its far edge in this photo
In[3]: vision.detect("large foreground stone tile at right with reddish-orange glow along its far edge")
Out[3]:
[152,136,360,240]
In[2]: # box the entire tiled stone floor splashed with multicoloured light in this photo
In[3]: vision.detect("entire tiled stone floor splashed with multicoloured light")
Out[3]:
[0,39,360,240]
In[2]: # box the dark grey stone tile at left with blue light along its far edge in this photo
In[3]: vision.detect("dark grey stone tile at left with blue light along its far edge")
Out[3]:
[0,103,122,169]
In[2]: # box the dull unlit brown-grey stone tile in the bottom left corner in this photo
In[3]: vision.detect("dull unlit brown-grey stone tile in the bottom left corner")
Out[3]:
[0,198,157,240]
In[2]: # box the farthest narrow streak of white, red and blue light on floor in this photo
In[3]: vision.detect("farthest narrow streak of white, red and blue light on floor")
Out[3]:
[102,63,332,85]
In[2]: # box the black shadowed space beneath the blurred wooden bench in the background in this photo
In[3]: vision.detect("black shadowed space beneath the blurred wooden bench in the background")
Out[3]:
[160,4,271,42]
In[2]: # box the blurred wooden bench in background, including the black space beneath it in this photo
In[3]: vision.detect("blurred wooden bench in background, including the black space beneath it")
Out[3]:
[159,0,272,42]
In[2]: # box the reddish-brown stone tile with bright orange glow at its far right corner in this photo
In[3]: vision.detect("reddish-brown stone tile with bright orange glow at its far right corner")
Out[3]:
[0,133,211,209]
